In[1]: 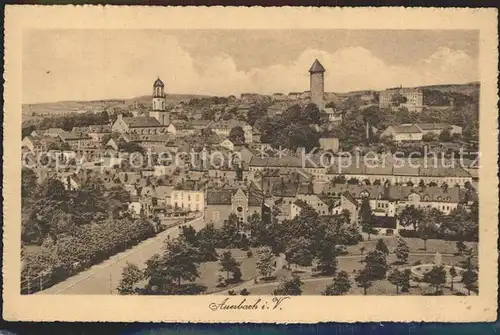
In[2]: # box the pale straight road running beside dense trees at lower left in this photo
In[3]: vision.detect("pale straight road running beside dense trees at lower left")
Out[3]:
[36,217,205,294]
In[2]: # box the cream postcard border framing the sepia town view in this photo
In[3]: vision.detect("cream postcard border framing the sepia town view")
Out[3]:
[3,5,498,323]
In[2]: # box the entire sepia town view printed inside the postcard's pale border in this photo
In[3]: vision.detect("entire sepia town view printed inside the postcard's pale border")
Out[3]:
[20,30,480,296]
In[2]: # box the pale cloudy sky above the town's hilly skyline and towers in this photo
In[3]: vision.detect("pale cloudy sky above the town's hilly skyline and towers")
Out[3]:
[22,30,479,103]
